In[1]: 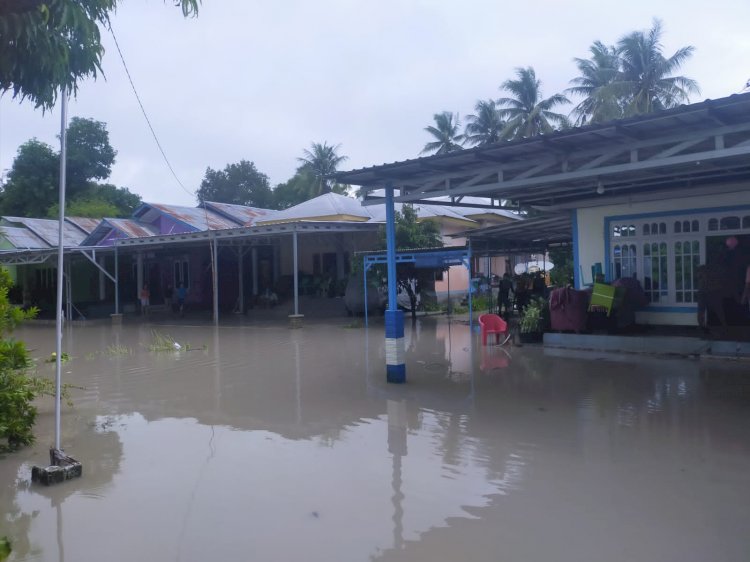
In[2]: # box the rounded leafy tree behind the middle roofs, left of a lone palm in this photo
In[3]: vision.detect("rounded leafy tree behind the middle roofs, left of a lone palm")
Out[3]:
[197,160,273,208]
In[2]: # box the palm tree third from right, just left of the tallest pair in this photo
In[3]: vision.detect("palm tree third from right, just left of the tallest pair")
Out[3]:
[497,67,570,139]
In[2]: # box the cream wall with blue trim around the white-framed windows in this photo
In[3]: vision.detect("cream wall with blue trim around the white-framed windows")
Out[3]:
[573,186,750,325]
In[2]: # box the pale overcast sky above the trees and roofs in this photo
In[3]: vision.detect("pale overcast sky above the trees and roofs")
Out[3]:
[0,0,750,205]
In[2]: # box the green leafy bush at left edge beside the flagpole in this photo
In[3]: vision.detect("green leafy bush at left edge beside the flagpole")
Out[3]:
[0,269,39,451]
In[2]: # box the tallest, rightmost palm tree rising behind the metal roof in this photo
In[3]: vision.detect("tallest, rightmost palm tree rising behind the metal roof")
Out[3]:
[610,19,700,116]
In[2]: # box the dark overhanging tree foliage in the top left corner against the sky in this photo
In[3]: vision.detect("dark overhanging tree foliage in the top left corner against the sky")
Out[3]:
[0,0,200,110]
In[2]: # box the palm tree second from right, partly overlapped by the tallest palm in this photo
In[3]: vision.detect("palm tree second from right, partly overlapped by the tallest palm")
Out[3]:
[566,41,623,126]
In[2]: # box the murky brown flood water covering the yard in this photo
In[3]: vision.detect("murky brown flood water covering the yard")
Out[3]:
[0,319,750,562]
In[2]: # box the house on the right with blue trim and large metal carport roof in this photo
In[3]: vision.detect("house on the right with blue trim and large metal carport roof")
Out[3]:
[336,93,750,325]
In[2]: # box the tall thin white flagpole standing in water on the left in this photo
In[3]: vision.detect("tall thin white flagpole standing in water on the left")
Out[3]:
[55,89,68,450]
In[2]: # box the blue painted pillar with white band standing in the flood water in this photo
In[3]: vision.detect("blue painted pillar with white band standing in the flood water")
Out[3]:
[384,184,406,383]
